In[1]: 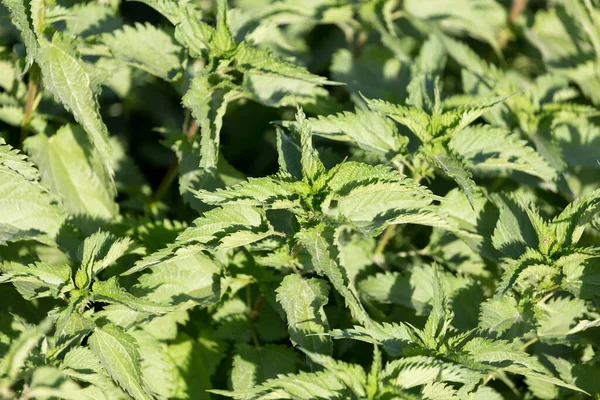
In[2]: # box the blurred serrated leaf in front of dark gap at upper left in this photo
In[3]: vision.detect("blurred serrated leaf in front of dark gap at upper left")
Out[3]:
[102,23,183,80]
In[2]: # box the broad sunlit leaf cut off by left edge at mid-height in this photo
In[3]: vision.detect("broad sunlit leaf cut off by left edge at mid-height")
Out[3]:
[0,139,66,243]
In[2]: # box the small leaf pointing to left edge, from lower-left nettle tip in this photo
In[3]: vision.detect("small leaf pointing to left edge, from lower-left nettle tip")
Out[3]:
[0,261,74,300]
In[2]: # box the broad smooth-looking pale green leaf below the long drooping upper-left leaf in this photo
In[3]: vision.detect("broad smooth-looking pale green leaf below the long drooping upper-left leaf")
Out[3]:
[24,125,119,218]
